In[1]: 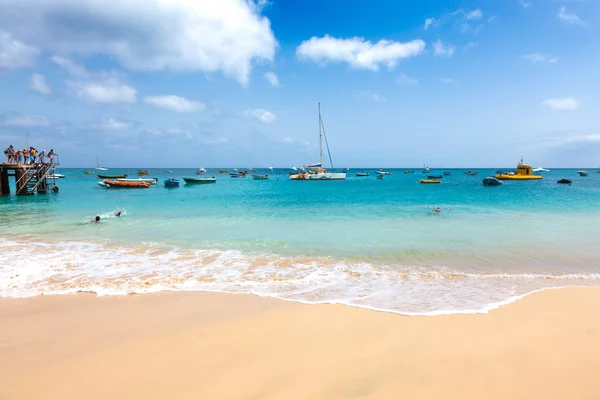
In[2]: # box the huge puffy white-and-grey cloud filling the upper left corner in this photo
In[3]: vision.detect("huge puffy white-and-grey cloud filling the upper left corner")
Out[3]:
[0,0,277,84]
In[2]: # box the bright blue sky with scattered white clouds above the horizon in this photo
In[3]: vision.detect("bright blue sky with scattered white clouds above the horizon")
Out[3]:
[0,0,600,168]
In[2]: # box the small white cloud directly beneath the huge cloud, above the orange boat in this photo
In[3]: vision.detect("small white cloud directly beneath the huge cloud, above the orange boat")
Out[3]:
[66,78,137,104]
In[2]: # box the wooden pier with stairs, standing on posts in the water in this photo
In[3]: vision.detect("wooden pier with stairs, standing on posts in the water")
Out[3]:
[0,163,58,196]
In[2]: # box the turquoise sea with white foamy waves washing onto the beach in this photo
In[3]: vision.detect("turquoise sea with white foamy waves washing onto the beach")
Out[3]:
[0,169,600,314]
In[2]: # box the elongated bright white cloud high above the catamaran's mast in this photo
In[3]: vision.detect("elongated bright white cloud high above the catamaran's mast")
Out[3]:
[296,35,425,71]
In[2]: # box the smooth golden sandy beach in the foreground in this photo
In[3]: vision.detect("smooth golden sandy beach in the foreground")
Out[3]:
[0,288,600,400]
